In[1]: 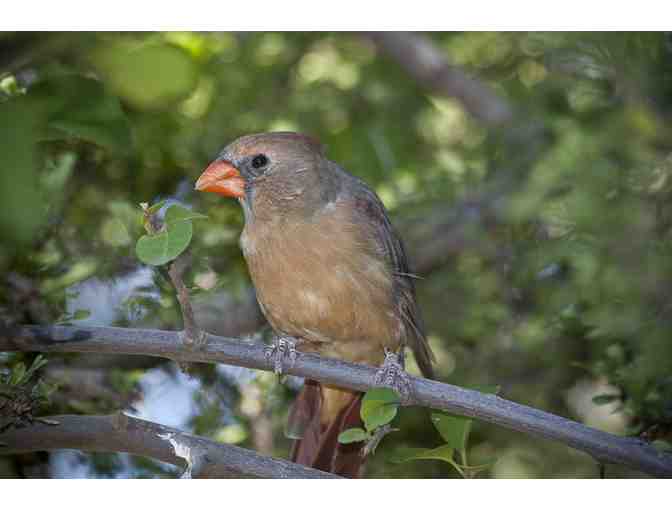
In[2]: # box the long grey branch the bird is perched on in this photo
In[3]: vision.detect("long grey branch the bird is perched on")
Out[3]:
[0,326,672,477]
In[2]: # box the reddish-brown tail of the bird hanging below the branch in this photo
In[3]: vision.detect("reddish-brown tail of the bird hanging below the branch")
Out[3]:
[287,380,364,478]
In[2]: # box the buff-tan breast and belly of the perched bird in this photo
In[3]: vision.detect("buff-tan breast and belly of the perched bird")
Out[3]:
[241,221,400,364]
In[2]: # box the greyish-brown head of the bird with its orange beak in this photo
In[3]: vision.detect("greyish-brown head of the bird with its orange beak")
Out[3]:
[195,132,335,218]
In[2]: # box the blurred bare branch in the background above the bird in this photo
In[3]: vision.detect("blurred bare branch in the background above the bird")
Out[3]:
[368,32,514,126]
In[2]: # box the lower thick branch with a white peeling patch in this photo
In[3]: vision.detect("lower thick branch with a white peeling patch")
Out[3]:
[0,413,338,478]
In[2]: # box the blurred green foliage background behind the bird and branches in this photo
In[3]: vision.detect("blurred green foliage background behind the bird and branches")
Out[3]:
[0,32,672,477]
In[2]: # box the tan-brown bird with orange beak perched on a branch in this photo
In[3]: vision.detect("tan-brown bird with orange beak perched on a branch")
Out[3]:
[195,132,434,477]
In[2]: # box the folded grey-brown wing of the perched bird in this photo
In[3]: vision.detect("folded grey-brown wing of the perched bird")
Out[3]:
[347,172,435,378]
